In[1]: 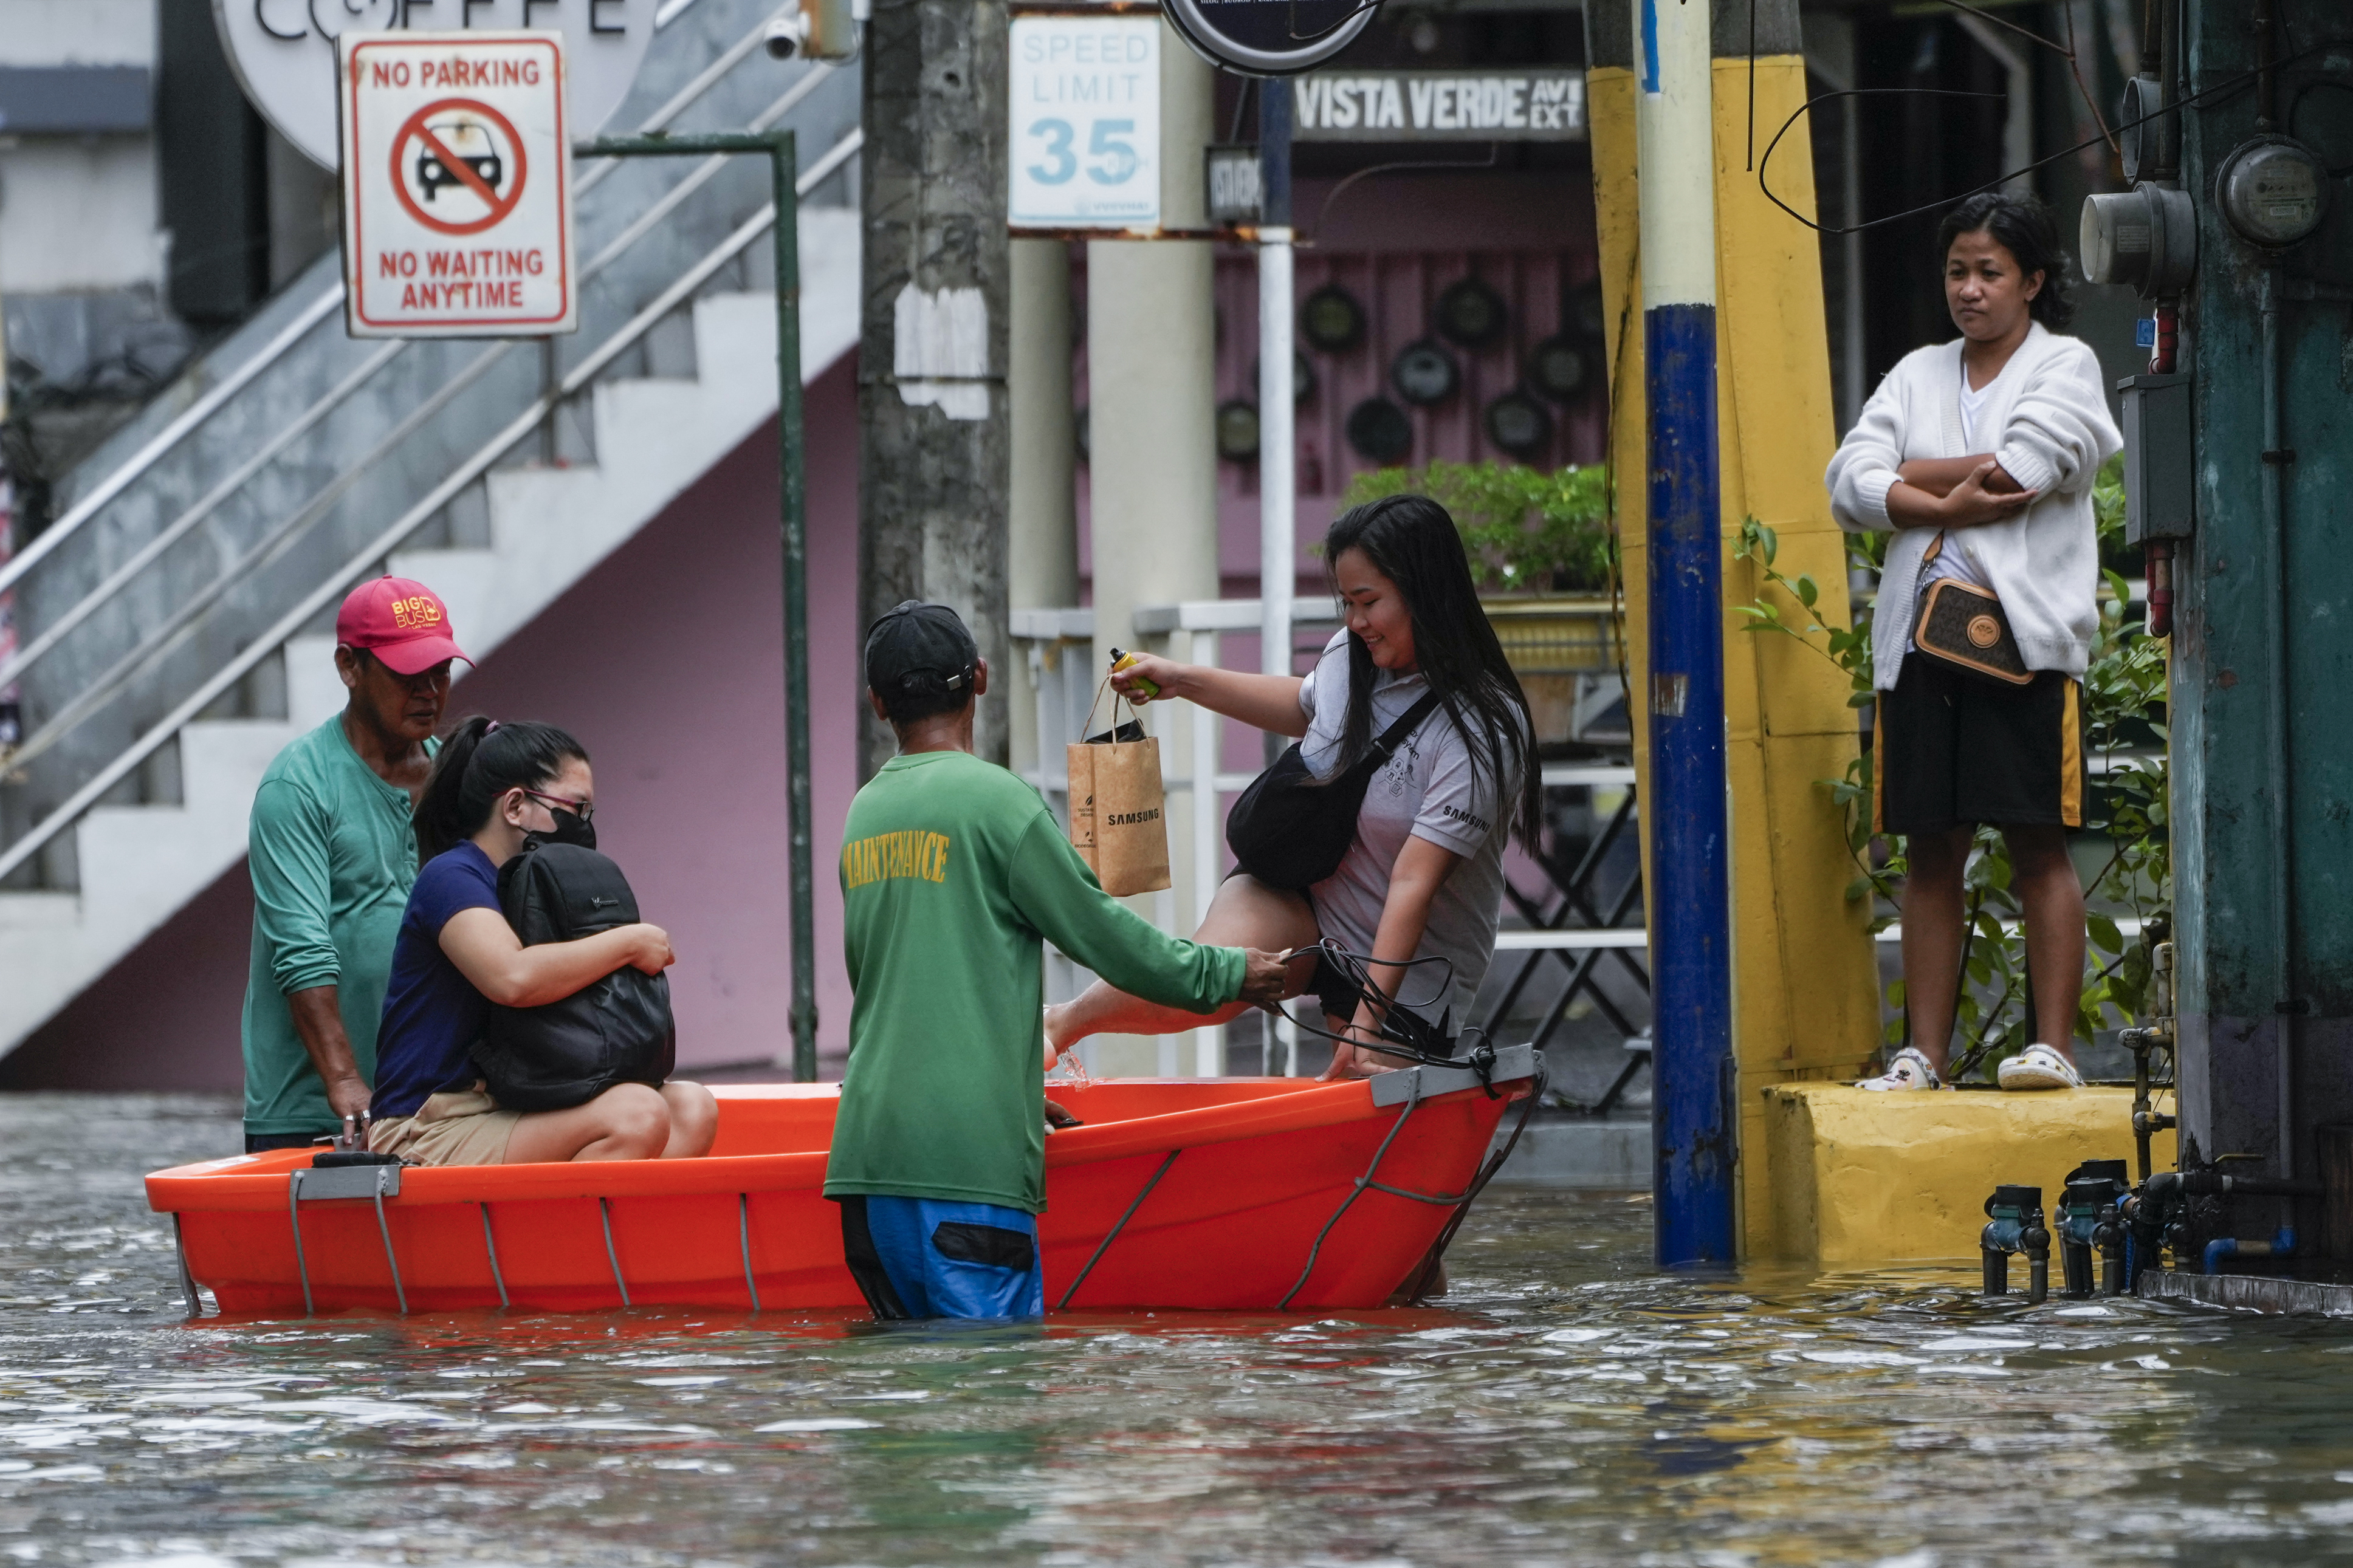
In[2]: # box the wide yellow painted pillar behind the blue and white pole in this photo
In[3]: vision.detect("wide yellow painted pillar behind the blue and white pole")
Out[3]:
[1586,0,1880,1255]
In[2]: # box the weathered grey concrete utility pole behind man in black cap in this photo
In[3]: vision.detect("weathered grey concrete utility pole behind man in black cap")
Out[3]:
[859,0,1009,778]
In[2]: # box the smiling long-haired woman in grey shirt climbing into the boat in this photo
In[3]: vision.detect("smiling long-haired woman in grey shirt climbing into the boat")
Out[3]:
[1045,496,1541,1077]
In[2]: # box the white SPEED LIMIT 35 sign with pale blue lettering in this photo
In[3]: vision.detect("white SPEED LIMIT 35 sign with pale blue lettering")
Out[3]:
[1007,16,1160,228]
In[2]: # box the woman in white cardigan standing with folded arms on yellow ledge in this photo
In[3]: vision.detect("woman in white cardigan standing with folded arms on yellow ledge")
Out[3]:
[1826,195,2123,1089]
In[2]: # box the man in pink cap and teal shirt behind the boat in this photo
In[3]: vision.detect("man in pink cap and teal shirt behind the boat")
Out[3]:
[245,576,473,1154]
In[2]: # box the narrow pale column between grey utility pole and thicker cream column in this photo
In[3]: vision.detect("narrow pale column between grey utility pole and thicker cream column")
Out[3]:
[998,240,1077,771]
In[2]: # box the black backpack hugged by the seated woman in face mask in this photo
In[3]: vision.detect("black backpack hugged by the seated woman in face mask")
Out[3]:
[473,839,678,1109]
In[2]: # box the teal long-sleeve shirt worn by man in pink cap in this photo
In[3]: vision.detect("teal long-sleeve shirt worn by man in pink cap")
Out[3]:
[245,714,431,1135]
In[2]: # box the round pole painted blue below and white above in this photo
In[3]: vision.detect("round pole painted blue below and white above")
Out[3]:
[1633,0,1739,1267]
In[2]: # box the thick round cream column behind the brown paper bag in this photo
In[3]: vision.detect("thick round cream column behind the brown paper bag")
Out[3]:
[1087,24,1217,1072]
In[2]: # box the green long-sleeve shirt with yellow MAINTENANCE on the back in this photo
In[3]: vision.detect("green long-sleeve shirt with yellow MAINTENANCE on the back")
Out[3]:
[826,752,1242,1213]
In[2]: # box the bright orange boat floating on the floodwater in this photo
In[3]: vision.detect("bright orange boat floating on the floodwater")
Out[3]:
[146,1046,1536,1316]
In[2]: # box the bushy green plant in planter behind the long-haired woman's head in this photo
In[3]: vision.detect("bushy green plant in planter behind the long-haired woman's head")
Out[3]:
[1341,460,1609,592]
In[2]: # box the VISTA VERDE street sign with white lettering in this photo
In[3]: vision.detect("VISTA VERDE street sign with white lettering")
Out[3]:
[1292,70,1586,141]
